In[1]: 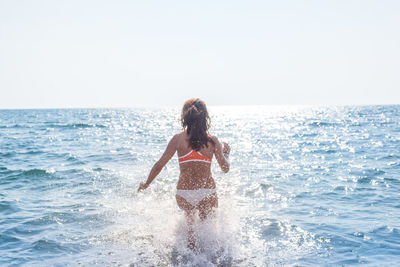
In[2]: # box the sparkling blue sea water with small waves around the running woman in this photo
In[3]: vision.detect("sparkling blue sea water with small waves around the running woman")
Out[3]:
[0,106,400,266]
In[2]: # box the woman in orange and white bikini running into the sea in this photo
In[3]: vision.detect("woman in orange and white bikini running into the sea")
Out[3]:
[138,98,230,249]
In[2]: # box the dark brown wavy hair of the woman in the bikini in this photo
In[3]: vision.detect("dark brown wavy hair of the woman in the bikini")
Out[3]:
[181,98,215,151]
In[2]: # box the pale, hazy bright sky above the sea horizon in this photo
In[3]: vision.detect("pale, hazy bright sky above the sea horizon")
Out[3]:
[0,0,400,109]
